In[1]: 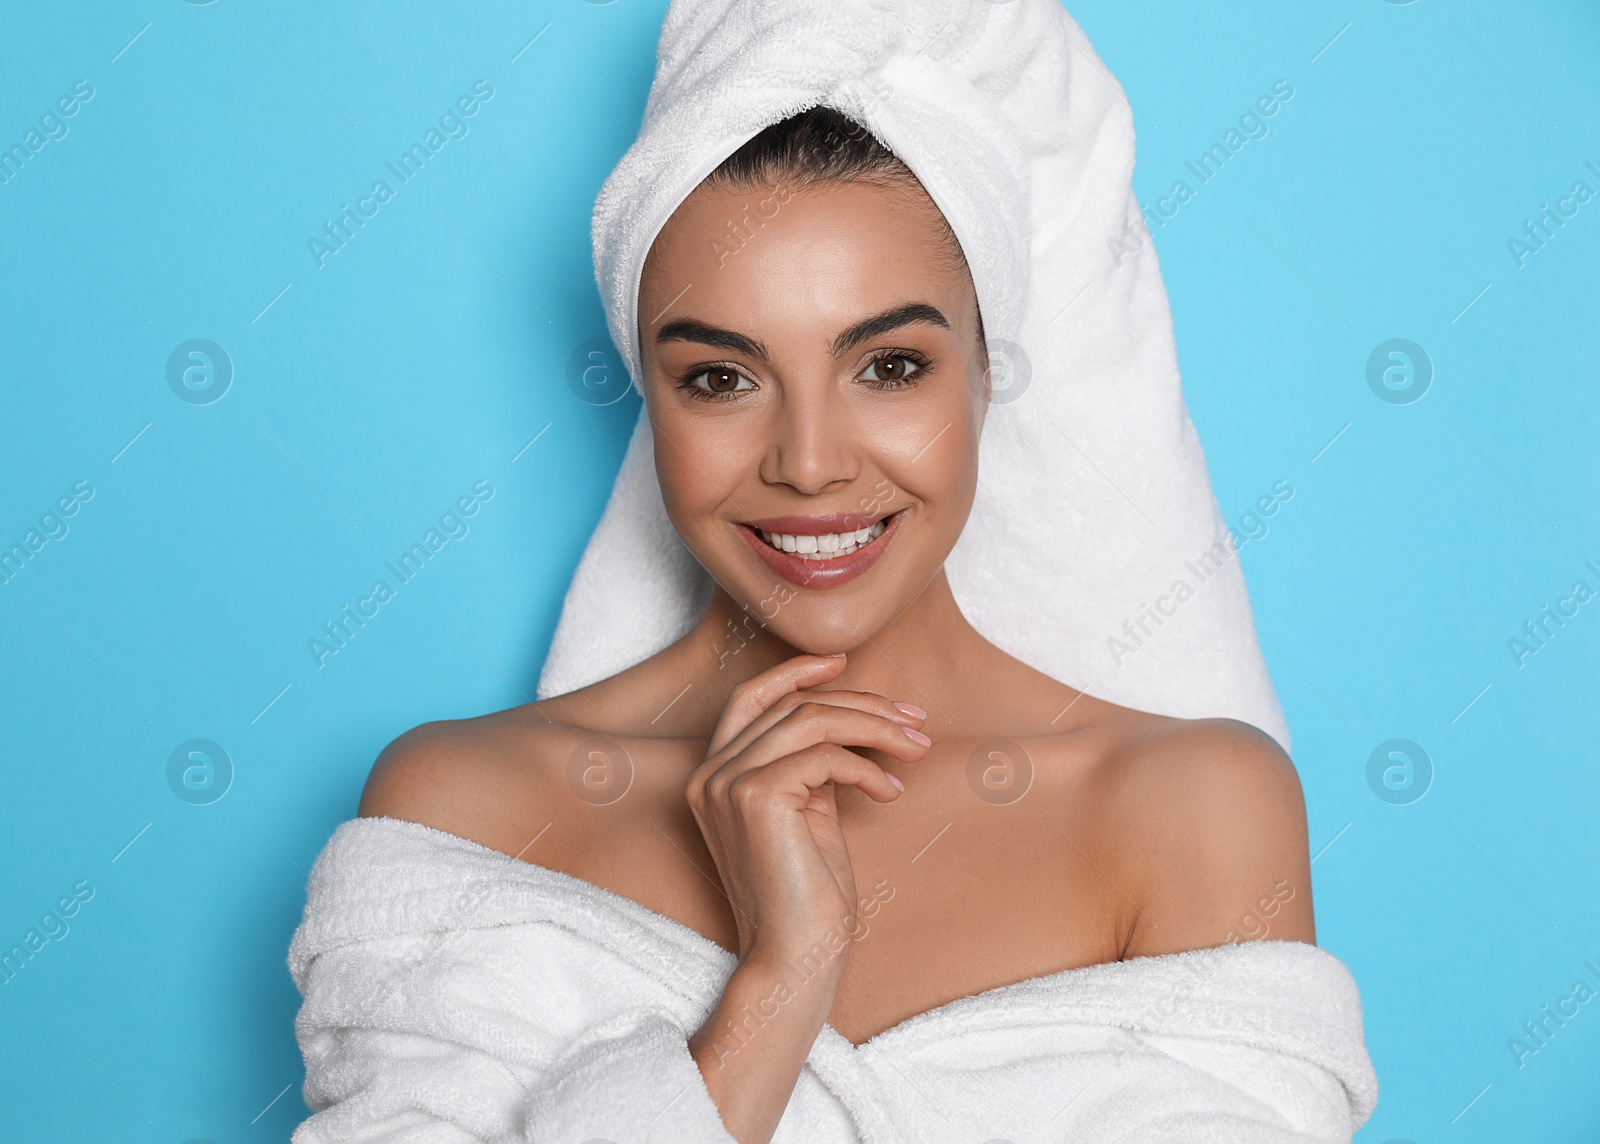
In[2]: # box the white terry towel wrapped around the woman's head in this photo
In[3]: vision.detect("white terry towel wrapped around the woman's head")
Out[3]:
[539,0,1288,747]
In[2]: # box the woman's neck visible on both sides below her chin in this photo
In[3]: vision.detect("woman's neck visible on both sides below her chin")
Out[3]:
[675,568,995,733]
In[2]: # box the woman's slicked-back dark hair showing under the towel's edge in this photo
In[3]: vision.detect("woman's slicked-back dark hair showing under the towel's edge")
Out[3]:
[706,107,982,299]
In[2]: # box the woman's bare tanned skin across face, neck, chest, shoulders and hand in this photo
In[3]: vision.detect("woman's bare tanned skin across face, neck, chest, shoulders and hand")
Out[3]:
[360,174,1315,1144]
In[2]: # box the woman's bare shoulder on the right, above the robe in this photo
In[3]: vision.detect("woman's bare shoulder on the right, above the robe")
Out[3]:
[1106,717,1317,957]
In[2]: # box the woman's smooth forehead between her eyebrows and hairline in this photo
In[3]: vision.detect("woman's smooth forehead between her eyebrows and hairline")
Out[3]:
[638,182,973,346]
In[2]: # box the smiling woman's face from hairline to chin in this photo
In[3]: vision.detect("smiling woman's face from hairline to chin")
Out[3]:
[638,174,987,653]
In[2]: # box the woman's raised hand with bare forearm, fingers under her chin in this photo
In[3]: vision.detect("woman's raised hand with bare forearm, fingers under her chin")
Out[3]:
[686,656,930,1142]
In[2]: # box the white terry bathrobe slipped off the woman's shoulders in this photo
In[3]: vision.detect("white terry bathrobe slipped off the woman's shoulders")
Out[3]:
[290,818,1378,1144]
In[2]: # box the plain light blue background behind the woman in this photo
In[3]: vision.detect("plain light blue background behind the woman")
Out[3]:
[0,0,1600,1144]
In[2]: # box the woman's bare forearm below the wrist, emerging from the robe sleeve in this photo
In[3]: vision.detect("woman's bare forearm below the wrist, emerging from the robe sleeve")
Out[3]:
[690,949,838,1144]
